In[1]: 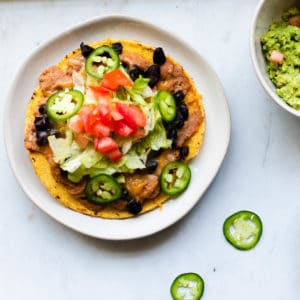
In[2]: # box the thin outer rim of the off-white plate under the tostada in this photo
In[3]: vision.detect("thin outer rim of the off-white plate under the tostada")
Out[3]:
[3,14,231,241]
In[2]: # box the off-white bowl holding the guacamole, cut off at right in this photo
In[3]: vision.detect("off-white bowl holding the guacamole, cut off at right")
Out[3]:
[250,0,300,117]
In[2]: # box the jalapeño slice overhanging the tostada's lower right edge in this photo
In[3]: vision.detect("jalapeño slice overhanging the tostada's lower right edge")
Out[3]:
[160,161,191,196]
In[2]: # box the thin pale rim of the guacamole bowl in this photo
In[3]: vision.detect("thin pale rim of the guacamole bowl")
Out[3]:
[250,0,300,118]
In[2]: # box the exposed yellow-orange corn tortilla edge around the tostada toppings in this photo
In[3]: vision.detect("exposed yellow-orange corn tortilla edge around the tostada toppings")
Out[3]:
[25,39,205,219]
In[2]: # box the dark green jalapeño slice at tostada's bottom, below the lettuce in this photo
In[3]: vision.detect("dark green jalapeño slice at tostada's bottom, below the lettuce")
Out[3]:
[85,174,122,204]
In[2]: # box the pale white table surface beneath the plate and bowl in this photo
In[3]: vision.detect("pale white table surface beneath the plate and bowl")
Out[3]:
[0,0,300,300]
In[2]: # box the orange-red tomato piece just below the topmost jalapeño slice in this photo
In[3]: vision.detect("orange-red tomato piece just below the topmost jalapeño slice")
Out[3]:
[100,69,133,91]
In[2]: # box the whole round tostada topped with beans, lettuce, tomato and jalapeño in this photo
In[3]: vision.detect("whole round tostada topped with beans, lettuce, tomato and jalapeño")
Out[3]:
[24,39,205,219]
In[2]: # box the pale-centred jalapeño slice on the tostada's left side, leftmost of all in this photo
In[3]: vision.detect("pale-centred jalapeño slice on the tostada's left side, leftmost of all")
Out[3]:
[46,90,84,122]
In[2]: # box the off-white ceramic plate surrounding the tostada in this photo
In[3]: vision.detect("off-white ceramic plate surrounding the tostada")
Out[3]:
[5,16,230,240]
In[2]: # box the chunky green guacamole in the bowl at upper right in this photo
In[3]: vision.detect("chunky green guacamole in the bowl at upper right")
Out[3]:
[261,7,300,110]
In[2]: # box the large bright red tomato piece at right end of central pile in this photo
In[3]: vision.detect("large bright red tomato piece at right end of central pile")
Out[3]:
[116,102,146,129]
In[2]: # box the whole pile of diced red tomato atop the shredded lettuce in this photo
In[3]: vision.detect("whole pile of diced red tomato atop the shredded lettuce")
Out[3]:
[69,69,146,161]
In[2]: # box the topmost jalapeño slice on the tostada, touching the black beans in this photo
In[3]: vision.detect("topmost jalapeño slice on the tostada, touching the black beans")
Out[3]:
[85,45,120,79]
